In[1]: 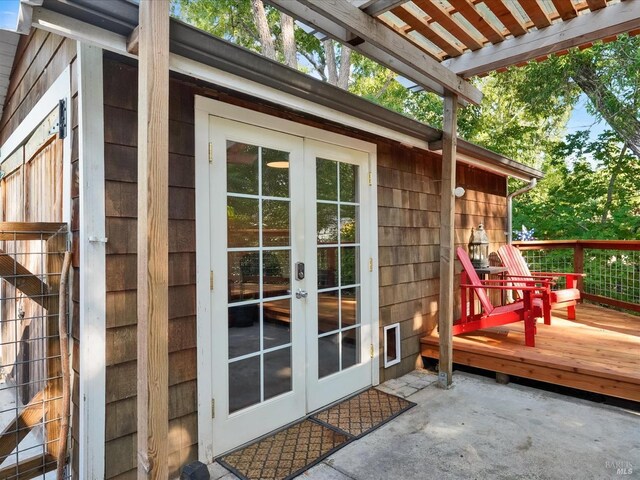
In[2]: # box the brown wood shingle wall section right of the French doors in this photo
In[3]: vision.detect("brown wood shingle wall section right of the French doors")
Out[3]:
[378,142,506,381]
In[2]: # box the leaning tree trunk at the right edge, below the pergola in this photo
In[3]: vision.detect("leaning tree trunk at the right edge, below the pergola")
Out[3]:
[571,60,640,158]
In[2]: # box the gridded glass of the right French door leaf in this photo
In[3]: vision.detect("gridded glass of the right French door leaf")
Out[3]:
[316,158,361,378]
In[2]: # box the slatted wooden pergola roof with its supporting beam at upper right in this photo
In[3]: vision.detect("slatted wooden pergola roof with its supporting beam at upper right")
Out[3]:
[350,0,640,78]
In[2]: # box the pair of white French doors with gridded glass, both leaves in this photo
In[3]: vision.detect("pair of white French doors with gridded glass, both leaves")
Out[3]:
[205,116,374,455]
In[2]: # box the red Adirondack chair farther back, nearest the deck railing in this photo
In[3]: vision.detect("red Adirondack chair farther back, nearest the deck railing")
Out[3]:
[498,245,584,325]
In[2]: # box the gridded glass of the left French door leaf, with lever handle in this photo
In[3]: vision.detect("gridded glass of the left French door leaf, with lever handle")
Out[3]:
[227,141,295,413]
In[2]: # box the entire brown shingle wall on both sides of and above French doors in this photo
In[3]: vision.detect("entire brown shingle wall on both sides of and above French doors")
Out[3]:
[104,56,506,479]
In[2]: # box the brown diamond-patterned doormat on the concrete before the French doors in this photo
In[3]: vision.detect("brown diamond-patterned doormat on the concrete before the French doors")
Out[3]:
[218,388,415,480]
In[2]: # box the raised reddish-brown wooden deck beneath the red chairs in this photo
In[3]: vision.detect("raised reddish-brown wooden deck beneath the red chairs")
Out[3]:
[421,304,640,401]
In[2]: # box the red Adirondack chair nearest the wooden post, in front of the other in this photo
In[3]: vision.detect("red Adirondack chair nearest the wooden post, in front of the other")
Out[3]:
[452,247,542,347]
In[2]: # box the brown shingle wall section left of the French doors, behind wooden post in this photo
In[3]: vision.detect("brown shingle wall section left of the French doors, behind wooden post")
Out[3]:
[104,59,198,479]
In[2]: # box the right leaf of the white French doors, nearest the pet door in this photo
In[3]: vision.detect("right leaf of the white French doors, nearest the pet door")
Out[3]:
[305,140,374,411]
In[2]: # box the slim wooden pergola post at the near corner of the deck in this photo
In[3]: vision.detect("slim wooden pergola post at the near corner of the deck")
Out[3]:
[438,93,464,388]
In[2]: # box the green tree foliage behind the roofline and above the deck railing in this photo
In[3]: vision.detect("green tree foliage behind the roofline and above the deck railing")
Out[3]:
[172,0,640,239]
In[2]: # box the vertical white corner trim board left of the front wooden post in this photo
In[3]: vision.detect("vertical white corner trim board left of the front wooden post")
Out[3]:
[77,42,107,480]
